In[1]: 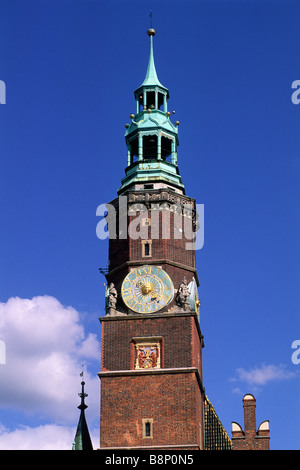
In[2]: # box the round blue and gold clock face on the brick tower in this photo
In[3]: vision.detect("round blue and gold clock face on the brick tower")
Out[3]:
[121,265,174,313]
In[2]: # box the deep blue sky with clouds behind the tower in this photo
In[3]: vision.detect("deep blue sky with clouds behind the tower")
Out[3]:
[0,0,300,449]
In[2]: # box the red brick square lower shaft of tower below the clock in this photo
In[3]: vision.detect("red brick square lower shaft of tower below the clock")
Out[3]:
[99,313,203,450]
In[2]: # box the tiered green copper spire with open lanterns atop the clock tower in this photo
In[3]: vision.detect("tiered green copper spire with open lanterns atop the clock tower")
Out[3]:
[118,27,184,195]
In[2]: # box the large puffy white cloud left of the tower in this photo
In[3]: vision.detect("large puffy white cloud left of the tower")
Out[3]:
[0,296,100,432]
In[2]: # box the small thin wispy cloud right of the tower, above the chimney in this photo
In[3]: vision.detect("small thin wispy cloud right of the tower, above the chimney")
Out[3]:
[232,364,295,385]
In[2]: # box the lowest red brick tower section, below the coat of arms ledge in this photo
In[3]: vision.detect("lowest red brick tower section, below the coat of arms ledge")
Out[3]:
[100,373,203,450]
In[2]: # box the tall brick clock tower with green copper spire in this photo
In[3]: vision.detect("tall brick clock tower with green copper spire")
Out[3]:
[99,28,205,450]
